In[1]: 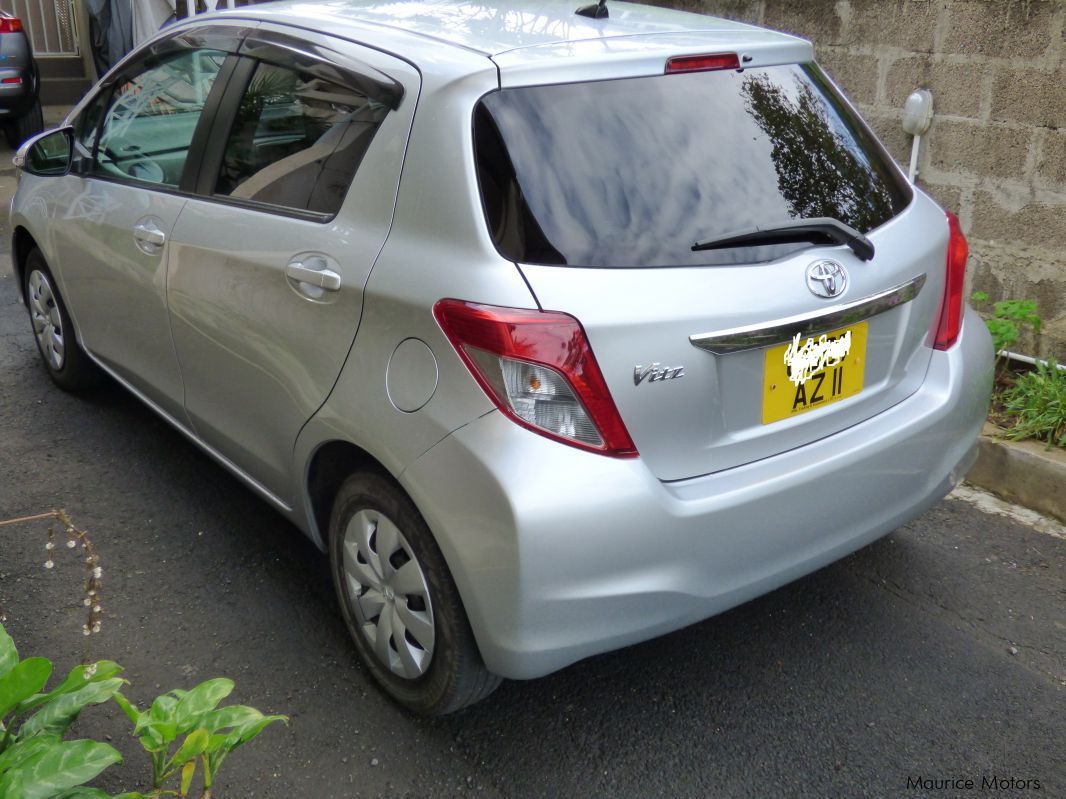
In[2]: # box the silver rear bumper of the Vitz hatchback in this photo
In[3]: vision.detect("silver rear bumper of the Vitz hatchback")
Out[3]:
[401,310,992,679]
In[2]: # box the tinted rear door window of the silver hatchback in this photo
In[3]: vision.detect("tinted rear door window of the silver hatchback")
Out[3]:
[215,63,388,214]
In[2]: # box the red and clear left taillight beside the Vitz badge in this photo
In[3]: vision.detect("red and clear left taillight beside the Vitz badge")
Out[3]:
[433,299,636,458]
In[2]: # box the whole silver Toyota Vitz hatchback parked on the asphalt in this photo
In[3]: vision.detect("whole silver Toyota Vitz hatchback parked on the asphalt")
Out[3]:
[11,0,991,714]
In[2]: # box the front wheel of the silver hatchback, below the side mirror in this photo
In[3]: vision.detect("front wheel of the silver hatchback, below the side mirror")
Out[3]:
[22,248,103,392]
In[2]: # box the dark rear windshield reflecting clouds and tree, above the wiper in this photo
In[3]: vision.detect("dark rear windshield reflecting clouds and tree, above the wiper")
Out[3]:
[474,64,911,266]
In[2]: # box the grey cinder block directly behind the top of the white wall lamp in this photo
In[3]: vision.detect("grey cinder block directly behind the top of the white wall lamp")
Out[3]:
[886,55,989,117]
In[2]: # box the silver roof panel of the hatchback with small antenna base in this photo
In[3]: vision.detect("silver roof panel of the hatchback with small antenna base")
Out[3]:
[231,0,797,58]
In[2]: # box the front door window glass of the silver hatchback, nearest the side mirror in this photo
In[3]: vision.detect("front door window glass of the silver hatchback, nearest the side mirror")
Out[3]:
[90,50,226,186]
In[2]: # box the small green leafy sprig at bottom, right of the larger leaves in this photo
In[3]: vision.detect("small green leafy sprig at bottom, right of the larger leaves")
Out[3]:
[115,678,288,799]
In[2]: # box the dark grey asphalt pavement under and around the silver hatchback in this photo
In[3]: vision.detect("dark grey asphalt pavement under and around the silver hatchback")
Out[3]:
[0,145,1066,799]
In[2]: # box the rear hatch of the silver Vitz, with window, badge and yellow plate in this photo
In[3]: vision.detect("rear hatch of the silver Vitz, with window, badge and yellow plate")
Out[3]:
[474,62,948,480]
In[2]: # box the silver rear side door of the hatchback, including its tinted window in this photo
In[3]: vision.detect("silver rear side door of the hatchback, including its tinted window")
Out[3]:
[167,25,419,503]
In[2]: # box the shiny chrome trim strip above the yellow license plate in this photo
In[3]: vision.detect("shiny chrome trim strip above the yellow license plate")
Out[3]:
[689,274,925,355]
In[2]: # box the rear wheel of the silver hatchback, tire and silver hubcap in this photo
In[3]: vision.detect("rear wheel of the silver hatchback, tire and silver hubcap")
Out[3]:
[329,473,500,716]
